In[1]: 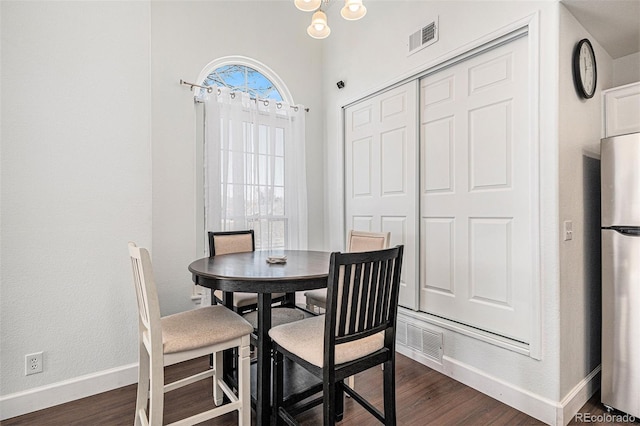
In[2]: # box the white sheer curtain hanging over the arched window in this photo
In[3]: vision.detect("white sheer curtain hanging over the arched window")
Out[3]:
[204,88,307,250]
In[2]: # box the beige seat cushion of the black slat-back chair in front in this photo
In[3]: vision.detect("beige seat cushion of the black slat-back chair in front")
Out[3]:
[269,315,384,367]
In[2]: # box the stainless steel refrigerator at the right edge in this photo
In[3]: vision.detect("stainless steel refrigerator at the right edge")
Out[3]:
[600,133,640,418]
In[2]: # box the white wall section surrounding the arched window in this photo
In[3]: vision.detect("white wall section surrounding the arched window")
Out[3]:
[151,1,324,314]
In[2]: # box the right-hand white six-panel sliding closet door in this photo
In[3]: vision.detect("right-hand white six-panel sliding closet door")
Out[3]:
[420,37,533,342]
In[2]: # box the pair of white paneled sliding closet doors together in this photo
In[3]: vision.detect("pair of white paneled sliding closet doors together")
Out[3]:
[345,34,537,343]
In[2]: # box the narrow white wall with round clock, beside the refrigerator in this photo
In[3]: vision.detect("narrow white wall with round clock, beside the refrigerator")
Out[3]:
[558,5,613,400]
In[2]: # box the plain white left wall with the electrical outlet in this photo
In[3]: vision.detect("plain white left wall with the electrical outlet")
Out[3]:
[0,1,151,400]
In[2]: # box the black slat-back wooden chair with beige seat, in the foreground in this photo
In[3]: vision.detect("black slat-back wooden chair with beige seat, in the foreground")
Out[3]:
[269,246,404,425]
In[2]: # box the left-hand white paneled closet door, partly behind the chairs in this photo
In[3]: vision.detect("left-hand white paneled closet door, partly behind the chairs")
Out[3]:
[344,81,418,309]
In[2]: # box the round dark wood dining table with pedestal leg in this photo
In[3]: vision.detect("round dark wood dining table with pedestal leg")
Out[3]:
[189,250,331,425]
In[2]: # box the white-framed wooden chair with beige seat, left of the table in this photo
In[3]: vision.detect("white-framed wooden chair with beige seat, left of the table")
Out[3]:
[129,243,253,426]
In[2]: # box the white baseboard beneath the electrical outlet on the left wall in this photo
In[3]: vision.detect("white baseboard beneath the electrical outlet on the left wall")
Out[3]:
[0,364,138,420]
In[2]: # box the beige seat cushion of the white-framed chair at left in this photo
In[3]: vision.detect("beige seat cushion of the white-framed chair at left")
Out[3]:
[161,305,253,354]
